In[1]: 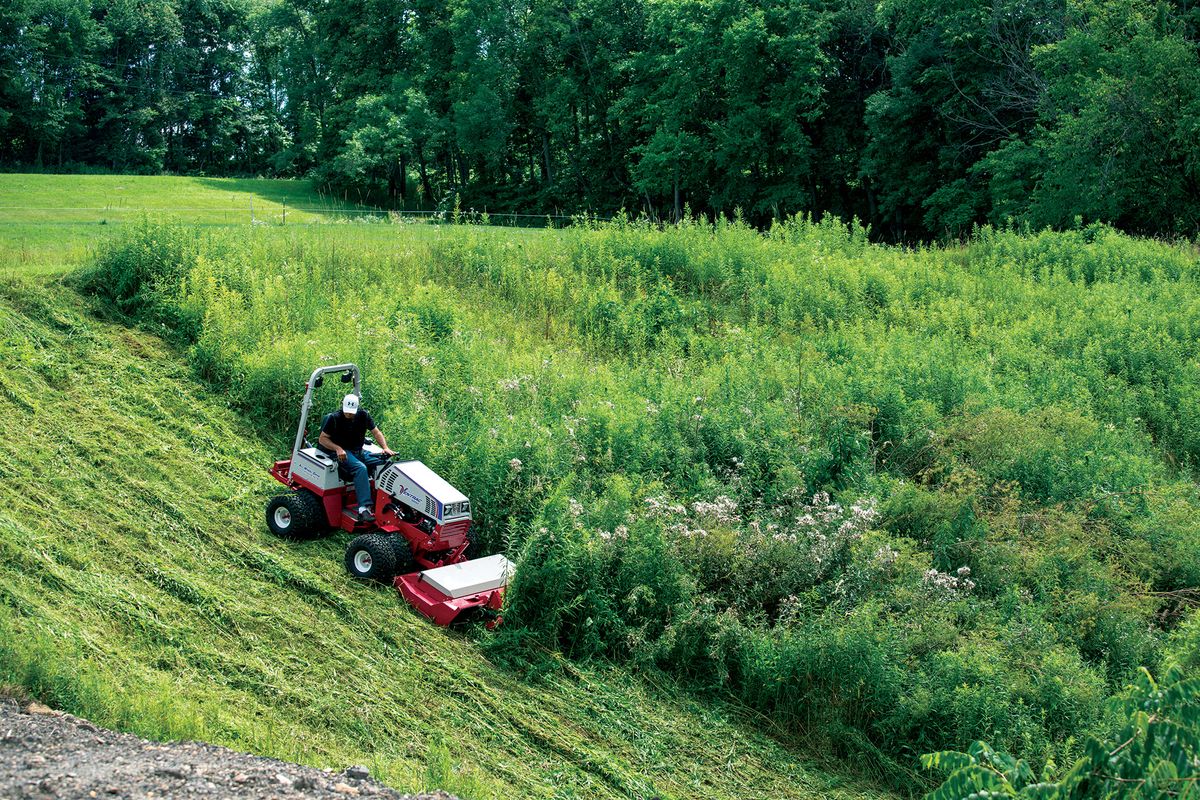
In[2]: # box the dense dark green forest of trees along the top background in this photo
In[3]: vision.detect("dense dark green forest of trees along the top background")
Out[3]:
[0,0,1200,241]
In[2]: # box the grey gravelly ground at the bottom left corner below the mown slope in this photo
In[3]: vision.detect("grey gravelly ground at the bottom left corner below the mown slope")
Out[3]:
[0,698,455,800]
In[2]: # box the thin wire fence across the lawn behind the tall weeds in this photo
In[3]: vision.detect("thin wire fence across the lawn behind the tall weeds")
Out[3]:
[0,203,585,228]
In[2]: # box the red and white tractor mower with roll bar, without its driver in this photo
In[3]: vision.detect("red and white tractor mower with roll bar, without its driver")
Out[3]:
[266,363,512,627]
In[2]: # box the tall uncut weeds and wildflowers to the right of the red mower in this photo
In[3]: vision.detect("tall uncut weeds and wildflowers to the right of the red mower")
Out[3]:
[83,218,1200,783]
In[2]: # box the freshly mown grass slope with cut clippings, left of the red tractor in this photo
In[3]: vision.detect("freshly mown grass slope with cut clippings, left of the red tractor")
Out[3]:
[0,282,870,798]
